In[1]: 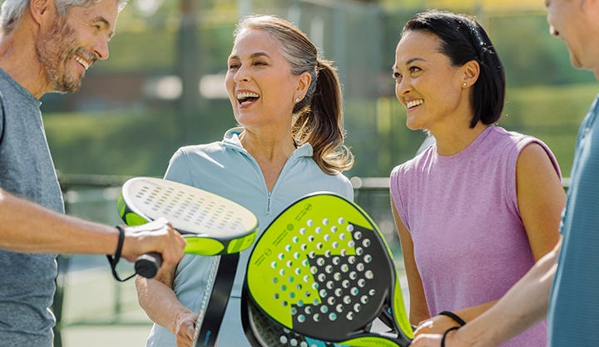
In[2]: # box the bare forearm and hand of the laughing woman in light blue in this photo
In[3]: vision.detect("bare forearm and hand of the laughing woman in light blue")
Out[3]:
[135,266,197,347]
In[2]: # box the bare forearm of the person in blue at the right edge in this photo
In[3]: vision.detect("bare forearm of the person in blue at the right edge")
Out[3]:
[411,240,561,347]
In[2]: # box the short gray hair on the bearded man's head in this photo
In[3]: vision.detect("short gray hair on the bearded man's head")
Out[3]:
[0,0,128,31]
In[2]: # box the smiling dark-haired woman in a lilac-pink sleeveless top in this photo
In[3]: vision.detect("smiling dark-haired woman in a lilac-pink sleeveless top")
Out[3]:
[391,11,565,347]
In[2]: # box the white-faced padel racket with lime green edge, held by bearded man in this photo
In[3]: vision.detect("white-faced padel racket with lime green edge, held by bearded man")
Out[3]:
[118,177,258,278]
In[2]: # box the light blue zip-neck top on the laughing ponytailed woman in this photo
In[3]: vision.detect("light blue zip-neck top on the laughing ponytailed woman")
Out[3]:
[147,128,353,347]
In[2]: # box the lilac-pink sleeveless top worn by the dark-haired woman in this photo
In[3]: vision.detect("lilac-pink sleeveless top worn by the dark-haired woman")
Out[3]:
[390,126,561,347]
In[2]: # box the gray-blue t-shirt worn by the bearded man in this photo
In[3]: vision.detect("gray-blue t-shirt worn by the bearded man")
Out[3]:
[0,69,64,347]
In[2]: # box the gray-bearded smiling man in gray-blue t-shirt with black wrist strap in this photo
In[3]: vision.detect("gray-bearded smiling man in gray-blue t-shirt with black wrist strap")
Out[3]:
[0,0,185,347]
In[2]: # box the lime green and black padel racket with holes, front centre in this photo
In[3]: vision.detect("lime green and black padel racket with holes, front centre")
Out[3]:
[242,193,413,347]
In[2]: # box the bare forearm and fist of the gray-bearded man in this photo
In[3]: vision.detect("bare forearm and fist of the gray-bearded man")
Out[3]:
[0,189,185,264]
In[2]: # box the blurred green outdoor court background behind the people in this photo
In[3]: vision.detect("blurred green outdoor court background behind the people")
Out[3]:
[50,0,599,347]
